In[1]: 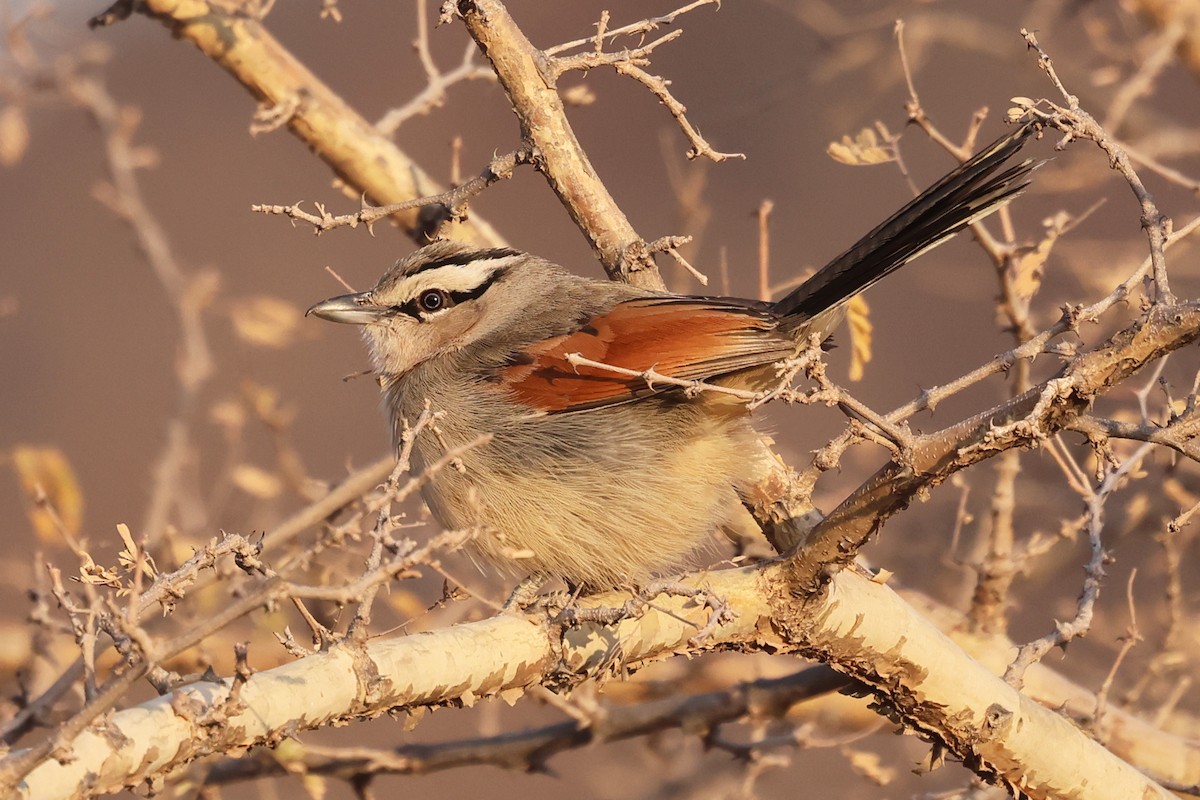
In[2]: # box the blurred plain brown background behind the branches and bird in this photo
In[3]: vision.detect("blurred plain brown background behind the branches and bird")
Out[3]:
[0,0,1200,798]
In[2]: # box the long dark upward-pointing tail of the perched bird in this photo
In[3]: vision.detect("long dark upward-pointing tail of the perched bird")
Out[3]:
[773,121,1043,327]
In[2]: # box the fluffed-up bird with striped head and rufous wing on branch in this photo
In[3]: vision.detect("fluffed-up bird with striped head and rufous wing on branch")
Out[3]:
[307,120,1040,590]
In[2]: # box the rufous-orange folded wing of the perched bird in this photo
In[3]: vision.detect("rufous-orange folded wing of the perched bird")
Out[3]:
[503,296,796,413]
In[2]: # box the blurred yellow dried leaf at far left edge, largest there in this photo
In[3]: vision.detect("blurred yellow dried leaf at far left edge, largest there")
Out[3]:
[12,445,83,542]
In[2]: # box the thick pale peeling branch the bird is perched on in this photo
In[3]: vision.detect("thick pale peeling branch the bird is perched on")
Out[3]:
[9,564,1170,800]
